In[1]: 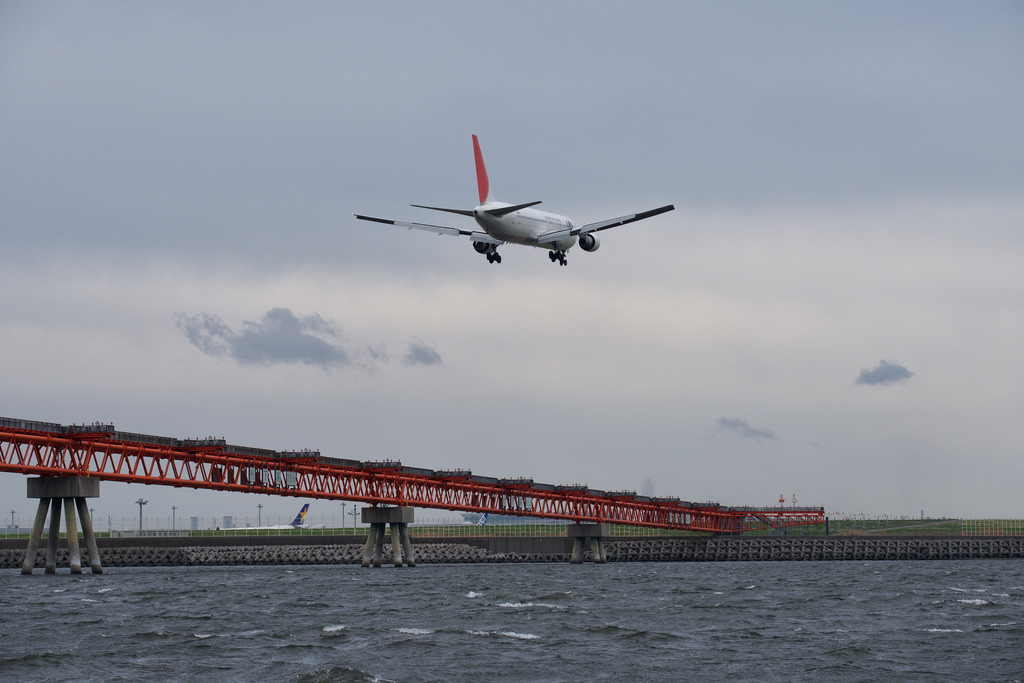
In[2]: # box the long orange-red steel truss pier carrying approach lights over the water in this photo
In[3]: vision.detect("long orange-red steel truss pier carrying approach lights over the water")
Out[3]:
[0,418,824,533]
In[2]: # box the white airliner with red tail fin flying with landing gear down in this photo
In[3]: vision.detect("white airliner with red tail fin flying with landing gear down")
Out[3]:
[353,135,676,265]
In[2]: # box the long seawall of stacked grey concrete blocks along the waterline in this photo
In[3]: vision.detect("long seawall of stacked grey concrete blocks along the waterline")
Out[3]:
[6,537,1024,568]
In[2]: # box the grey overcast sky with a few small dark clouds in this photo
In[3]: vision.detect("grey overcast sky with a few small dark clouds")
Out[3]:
[0,1,1024,527]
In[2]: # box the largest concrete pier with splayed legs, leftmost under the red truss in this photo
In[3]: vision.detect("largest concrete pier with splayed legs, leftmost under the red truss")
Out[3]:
[22,477,103,573]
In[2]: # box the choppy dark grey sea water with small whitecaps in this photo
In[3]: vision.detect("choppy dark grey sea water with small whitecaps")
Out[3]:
[0,560,1024,683]
